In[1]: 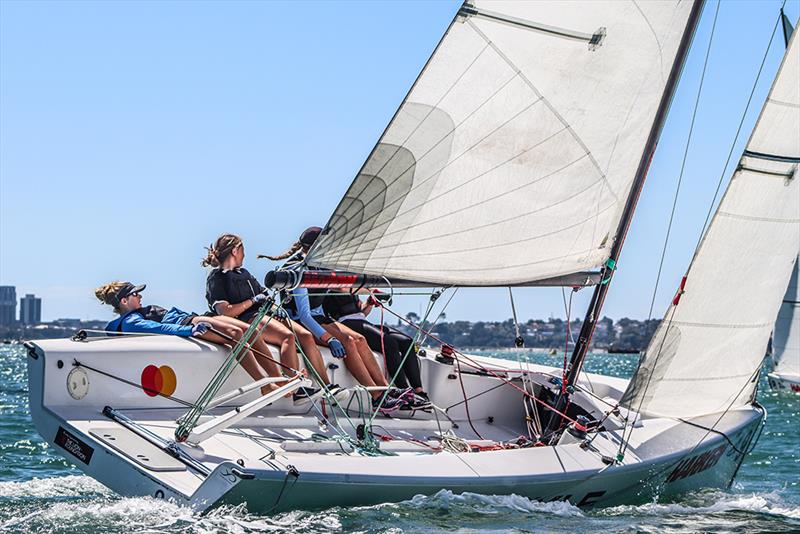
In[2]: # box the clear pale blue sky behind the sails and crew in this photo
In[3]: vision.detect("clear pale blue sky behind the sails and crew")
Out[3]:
[0,0,800,320]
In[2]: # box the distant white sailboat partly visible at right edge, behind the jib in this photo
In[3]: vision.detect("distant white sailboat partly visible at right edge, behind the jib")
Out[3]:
[767,259,800,393]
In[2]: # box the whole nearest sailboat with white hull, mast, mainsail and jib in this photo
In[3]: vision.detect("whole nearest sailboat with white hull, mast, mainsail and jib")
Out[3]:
[26,0,800,513]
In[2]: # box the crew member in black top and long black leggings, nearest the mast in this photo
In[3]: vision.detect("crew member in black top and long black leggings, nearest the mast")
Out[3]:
[322,291,430,408]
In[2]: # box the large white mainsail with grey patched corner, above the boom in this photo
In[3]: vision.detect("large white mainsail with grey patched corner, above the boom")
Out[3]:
[308,0,692,285]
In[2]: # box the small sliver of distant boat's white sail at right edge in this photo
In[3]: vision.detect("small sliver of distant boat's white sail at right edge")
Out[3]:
[772,258,800,381]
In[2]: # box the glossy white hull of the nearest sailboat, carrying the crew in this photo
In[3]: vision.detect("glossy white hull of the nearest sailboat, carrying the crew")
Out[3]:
[23,336,764,512]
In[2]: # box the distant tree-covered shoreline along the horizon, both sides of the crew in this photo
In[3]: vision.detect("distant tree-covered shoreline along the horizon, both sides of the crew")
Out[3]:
[0,312,660,352]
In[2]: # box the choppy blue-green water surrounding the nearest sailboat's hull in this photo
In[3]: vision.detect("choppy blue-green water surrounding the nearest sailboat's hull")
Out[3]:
[0,346,800,534]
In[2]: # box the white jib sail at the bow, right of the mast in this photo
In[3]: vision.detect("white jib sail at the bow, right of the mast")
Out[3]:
[623,32,800,417]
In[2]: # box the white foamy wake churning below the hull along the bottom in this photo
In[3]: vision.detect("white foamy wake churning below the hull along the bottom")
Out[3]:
[0,476,800,533]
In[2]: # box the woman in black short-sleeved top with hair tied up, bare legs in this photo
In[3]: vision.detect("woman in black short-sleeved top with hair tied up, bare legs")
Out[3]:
[203,234,339,398]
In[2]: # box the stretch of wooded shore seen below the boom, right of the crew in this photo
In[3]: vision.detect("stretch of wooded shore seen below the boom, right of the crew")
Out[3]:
[392,313,661,352]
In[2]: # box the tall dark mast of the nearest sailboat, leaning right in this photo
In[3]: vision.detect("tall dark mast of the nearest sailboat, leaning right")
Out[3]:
[545,0,705,440]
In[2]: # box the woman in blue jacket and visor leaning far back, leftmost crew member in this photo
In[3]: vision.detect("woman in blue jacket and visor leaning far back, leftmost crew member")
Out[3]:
[94,282,280,394]
